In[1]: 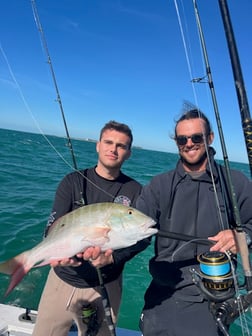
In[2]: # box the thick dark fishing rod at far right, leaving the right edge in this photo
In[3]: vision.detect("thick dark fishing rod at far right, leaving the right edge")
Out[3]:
[219,0,252,177]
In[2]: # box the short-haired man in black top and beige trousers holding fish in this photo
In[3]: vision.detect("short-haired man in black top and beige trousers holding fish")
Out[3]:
[33,121,149,336]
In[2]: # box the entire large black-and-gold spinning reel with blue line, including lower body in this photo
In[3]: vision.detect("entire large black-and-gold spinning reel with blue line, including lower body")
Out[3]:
[191,251,252,336]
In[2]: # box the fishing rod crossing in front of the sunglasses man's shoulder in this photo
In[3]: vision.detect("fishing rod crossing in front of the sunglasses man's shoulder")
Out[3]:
[193,0,252,335]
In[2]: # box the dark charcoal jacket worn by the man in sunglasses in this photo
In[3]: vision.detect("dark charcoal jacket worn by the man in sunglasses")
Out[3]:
[137,152,252,301]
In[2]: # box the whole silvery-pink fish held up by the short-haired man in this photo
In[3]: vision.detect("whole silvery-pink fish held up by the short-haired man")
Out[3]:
[0,202,158,296]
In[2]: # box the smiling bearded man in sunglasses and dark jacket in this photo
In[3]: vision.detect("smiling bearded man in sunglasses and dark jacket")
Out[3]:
[137,108,252,336]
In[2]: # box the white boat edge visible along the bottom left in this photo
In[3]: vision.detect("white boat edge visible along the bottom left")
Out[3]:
[0,304,141,336]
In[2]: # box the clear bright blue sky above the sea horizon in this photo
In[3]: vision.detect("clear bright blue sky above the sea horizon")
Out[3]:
[0,0,252,163]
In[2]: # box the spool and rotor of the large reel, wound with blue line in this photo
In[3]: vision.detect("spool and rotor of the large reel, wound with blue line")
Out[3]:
[191,251,235,303]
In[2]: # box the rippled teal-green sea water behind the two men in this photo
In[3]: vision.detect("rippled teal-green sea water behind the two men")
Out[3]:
[0,129,252,336]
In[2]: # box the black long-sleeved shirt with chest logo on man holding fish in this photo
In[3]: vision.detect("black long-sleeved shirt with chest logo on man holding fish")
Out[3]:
[48,167,150,288]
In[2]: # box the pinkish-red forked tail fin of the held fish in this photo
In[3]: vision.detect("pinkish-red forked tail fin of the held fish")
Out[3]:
[0,252,32,296]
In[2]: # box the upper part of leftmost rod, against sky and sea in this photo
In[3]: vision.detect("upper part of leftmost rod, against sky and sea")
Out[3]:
[31,0,77,170]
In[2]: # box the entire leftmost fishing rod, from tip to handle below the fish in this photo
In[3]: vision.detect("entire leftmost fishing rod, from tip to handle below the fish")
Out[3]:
[31,0,116,336]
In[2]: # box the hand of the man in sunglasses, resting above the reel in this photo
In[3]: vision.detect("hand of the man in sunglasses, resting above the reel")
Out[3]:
[208,230,238,254]
